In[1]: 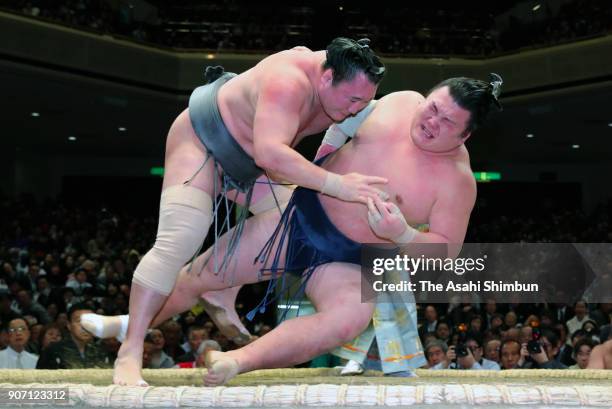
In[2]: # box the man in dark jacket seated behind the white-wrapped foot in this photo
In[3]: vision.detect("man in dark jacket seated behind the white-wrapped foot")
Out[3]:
[36,304,112,369]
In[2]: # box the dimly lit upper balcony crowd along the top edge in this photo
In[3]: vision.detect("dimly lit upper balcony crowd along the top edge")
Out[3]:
[3,0,612,57]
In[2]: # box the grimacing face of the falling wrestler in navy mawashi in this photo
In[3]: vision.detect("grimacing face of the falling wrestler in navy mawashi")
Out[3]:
[410,87,470,153]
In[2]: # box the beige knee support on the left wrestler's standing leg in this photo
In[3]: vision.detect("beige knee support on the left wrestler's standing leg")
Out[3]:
[133,185,213,295]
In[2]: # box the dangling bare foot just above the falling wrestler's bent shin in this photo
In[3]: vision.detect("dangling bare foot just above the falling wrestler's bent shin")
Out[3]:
[201,287,252,346]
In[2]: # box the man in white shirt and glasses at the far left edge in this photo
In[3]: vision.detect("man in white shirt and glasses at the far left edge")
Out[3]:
[0,318,38,369]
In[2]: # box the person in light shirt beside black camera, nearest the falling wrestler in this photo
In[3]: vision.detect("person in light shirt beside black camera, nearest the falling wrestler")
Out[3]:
[430,332,500,371]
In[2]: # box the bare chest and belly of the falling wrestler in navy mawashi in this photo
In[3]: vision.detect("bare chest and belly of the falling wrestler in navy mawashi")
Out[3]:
[319,92,469,243]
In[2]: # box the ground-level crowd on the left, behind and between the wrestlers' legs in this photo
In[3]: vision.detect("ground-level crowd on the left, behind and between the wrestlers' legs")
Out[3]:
[0,192,274,369]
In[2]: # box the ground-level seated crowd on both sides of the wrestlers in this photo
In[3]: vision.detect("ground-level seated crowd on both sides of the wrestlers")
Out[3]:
[0,188,612,369]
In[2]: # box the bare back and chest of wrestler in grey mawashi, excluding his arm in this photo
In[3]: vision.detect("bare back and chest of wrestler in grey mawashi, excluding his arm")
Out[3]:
[218,49,340,156]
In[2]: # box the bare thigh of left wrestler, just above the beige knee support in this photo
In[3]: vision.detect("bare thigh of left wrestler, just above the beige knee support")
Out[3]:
[162,109,220,196]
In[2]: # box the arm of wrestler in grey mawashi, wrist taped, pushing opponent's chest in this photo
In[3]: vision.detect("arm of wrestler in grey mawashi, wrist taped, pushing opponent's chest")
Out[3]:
[253,75,387,203]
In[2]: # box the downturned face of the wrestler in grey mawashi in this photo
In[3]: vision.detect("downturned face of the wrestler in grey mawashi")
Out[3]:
[319,70,377,122]
